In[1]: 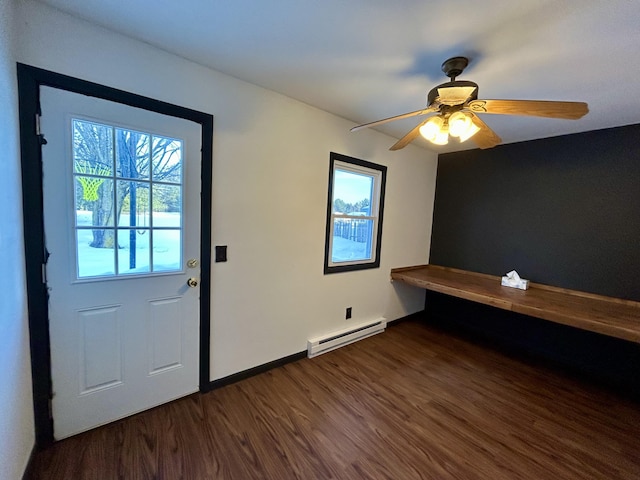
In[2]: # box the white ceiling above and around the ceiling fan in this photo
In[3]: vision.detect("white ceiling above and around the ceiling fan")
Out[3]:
[37,0,640,151]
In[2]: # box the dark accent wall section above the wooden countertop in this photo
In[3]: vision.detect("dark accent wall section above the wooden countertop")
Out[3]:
[430,125,640,301]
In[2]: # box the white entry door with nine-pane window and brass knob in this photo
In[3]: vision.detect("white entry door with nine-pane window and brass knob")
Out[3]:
[41,87,201,439]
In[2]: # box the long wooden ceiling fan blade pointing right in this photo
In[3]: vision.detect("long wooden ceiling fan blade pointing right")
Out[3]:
[466,100,589,120]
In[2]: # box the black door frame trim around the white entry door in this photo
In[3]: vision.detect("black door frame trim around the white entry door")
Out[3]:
[17,63,213,448]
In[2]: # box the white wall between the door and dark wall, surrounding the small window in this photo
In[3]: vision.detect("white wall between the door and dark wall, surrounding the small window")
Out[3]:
[18,0,436,379]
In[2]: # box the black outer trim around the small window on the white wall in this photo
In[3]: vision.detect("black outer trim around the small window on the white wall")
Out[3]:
[324,152,387,275]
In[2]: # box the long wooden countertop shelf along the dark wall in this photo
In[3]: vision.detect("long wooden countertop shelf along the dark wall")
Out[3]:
[391,265,640,343]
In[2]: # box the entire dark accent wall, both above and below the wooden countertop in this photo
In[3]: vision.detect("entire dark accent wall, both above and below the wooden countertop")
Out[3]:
[426,125,640,400]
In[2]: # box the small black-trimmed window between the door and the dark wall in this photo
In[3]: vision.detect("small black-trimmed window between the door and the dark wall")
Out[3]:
[324,152,387,273]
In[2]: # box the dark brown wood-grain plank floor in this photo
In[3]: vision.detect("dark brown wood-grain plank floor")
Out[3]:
[29,322,640,480]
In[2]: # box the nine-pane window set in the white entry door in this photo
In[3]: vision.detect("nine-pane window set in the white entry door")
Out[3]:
[72,119,183,279]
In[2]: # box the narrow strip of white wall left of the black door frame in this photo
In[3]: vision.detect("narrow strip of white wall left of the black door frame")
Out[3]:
[0,0,35,480]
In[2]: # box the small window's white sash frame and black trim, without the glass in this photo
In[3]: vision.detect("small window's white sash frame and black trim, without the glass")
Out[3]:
[324,152,387,274]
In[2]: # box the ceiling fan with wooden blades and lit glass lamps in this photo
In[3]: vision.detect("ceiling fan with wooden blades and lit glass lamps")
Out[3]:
[351,57,589,150]
